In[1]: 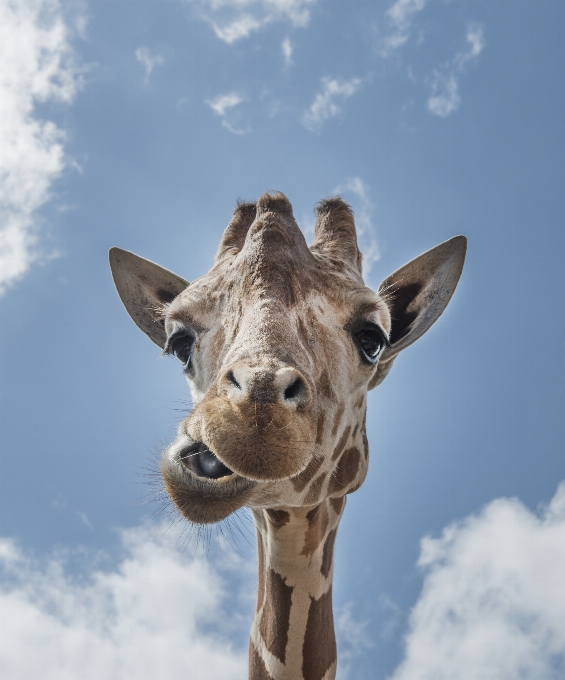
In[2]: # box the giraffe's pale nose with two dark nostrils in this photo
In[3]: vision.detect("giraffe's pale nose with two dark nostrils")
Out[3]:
[222,362,310,408]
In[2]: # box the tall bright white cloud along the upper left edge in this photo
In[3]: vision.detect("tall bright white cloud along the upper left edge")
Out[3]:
[0,0,80,295]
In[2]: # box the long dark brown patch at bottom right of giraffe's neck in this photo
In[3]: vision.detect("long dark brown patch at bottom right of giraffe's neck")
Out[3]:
[302,587,337,680]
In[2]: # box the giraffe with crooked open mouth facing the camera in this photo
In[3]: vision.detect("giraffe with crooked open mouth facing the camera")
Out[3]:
[110,192,466,680]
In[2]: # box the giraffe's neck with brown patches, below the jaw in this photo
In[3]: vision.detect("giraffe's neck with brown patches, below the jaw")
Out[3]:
[249,497,345,680]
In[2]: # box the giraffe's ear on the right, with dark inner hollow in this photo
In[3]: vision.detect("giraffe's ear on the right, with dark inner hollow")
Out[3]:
[369,236,467,389]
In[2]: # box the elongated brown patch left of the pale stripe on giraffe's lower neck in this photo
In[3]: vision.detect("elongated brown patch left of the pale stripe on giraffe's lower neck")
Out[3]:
[259,569,294,663]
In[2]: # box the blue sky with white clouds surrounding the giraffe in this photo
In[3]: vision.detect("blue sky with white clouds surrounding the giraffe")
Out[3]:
[0,0,565,680]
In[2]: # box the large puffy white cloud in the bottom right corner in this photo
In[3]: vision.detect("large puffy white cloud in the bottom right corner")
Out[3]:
[390,482,565,680]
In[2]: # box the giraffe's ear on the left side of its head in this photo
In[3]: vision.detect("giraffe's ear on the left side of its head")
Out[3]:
[109,248,189,348]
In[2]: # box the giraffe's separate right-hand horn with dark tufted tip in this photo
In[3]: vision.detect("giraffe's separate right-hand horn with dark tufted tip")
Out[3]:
[310,198,363,275]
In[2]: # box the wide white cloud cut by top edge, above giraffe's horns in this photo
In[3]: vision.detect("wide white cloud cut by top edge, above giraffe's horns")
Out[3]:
[185,0,316,45]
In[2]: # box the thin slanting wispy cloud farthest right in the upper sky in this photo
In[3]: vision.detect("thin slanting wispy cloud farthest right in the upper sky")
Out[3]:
[428,24,486,118]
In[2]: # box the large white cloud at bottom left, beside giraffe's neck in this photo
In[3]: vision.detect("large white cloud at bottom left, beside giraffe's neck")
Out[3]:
[0,529,252,680]
